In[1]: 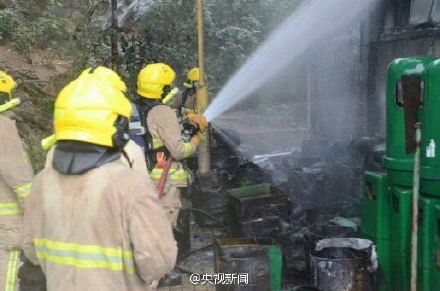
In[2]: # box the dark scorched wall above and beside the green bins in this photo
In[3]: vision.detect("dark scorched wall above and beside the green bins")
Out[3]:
[368,0,440,136]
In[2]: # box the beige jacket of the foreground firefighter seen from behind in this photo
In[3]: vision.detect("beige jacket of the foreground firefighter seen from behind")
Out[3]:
[24,155,177,291]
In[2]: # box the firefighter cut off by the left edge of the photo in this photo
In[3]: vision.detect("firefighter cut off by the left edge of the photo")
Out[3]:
[0,71,34,291]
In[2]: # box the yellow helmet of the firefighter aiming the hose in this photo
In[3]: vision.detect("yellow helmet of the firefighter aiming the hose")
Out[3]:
[137,63,176,99]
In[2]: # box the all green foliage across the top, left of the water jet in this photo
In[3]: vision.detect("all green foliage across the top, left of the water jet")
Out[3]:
[0,0,301,92]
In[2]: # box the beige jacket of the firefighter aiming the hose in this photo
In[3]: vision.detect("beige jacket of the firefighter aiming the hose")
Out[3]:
[146,105,197,187]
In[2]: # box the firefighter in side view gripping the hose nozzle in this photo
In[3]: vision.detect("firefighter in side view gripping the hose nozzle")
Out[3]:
[136,63,207,226]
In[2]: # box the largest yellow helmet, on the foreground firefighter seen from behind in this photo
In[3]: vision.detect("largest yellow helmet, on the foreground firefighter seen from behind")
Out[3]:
[54,78,131,148]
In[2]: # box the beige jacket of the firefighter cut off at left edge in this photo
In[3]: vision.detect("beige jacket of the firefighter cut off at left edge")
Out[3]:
[0,114,33,250]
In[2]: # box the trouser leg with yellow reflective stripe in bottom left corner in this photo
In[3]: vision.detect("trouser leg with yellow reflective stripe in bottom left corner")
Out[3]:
[0,248,20,291]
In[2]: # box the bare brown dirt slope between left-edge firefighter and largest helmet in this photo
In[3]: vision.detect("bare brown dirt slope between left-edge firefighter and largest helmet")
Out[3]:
[0,46,71,172]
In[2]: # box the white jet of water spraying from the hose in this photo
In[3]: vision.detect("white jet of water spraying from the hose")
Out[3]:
[205,0,376,121]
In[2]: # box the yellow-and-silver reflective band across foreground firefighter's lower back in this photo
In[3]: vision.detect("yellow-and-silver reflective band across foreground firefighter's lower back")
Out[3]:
[33,239,135,273]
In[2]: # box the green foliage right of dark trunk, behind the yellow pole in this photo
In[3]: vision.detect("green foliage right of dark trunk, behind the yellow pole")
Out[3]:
[119,0,300,92]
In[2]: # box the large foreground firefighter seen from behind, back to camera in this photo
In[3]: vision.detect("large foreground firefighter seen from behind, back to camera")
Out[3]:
[24,78,177,291]
